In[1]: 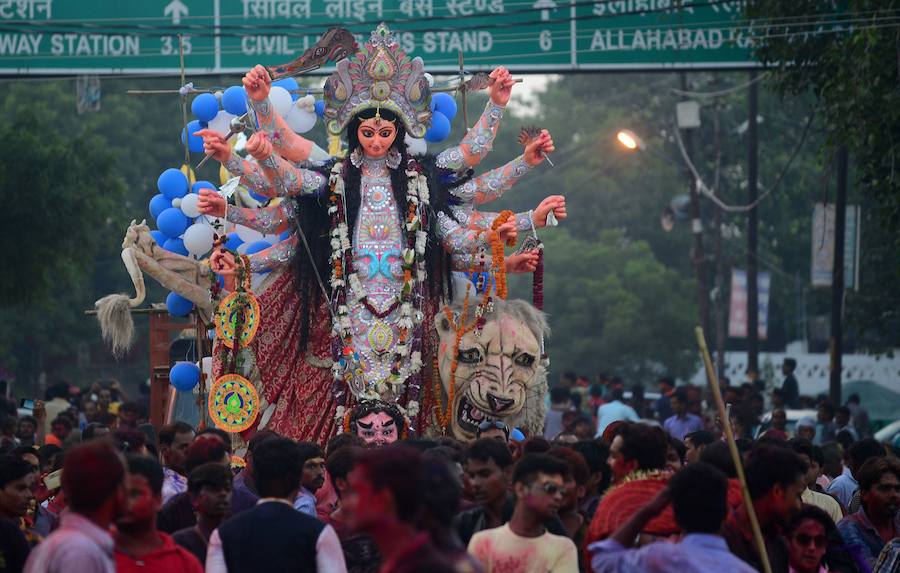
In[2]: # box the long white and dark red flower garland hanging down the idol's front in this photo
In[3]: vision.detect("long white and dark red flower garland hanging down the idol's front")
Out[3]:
[328,154,429,427]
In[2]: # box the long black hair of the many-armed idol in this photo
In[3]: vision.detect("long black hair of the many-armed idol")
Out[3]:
[291,105,472,350]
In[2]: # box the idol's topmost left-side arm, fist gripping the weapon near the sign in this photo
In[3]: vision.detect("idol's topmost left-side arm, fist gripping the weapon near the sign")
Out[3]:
[242,66,312,163]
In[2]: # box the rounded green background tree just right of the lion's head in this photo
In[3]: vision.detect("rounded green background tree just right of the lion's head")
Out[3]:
[513,229,697,383]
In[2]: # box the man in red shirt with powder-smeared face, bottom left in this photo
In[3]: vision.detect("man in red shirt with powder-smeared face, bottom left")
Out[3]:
[115,454,203,573]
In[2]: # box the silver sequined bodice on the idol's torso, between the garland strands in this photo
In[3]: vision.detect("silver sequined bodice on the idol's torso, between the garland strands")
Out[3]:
[348,158,403,388]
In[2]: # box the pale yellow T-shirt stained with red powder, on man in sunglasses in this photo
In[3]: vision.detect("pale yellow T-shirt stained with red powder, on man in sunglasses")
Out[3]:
[469,523,578,573]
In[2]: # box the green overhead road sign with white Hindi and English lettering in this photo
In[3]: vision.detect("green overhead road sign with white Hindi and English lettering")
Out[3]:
[0,0,756,74]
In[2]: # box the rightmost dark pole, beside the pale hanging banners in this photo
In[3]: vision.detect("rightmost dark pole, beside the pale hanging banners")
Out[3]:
[828,149,848,406]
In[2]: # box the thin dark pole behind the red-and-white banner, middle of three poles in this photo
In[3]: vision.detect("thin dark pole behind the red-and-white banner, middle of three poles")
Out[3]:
[747,70,759,374]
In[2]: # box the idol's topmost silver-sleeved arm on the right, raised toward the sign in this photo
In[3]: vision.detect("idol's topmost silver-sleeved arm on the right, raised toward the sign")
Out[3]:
[436,68,516,171]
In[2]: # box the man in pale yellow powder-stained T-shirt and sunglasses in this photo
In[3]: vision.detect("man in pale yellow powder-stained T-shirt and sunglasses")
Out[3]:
[469,454,578,573]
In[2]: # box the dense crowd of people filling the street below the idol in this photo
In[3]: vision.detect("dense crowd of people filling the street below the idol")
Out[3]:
[0,363,900,573]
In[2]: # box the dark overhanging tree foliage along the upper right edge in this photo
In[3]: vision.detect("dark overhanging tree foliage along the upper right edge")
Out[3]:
[747,0,900,351]
